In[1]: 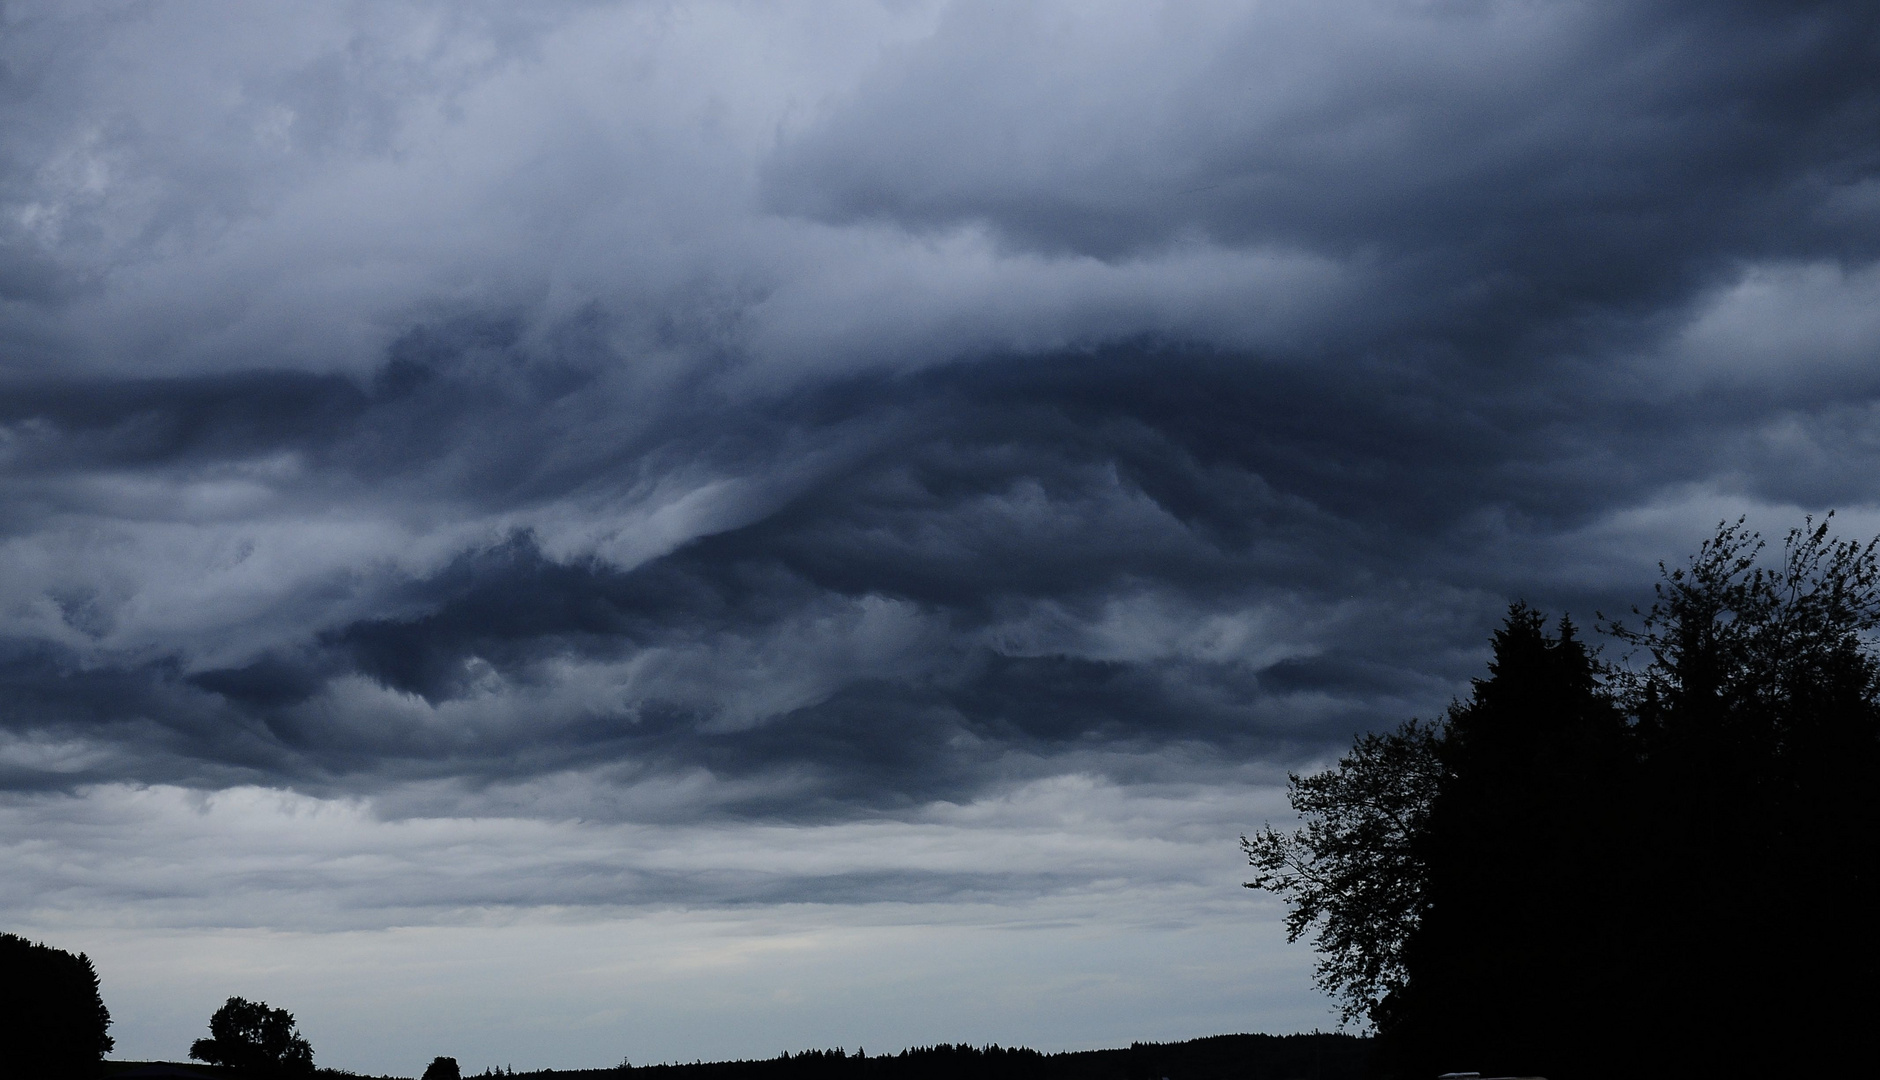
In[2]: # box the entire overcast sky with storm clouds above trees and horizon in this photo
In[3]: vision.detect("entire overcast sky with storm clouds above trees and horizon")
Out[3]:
[0,0,1880,1074]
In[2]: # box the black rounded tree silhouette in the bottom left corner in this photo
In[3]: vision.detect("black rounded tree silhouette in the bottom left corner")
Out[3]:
[0,933,113,1080]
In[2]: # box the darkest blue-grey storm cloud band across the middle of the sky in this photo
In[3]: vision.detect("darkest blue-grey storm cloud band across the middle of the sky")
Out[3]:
[4,333,1872,817]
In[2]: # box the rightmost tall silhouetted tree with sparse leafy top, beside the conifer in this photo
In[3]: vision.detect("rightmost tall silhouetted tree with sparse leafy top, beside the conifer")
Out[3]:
[1609,519,1880,1072]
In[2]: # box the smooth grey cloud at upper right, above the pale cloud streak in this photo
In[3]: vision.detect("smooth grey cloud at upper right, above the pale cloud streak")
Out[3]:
[765,2,1880,297]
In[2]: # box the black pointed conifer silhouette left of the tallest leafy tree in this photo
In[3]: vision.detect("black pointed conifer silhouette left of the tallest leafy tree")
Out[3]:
[1376,604,1632,1076]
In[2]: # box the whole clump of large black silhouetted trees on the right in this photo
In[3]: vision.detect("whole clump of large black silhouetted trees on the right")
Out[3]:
[1243,521,1880,1076]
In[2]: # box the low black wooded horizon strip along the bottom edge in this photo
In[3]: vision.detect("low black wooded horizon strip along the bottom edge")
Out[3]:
[105,1033,1371,1080]
